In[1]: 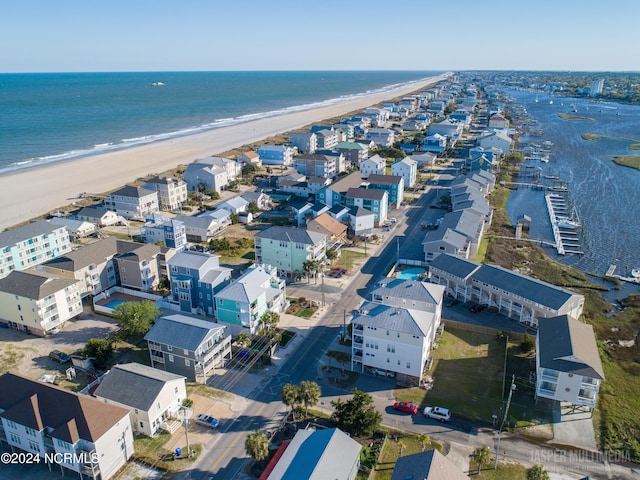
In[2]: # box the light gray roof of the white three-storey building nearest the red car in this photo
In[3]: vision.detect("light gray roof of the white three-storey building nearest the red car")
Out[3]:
[352,302,433,337]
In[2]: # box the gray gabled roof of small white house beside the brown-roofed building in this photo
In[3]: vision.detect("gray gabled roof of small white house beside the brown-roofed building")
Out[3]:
[94,363,185,411]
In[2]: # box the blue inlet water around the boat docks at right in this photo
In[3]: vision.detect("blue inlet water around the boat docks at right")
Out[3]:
[507,90,640,282]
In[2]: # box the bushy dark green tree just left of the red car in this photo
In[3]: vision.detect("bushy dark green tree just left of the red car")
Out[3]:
[331,388,382,436]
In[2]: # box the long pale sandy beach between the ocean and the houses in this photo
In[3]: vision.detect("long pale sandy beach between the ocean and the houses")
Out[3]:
[0,77,448,230]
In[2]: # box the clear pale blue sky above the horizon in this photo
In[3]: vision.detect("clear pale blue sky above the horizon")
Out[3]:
[0,0,640,73]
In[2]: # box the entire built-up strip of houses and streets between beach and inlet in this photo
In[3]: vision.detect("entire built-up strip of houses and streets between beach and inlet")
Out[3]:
[0,72,640,480]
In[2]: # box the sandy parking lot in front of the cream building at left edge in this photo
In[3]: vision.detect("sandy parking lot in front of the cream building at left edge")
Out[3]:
[0,309,118,379]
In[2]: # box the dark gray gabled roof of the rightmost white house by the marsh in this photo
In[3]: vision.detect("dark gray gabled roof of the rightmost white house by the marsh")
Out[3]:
[537,315,604,380]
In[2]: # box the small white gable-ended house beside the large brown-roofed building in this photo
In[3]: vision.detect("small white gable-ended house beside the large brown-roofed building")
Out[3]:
[93,363,187,437]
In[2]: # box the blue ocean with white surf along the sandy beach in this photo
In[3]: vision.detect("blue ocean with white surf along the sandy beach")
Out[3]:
[0,71,442,174]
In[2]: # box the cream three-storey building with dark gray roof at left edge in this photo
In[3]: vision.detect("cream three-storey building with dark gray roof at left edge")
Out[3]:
[0,269,82,336]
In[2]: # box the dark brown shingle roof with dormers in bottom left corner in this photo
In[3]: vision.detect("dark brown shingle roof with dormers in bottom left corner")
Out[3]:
[0,373,129,443]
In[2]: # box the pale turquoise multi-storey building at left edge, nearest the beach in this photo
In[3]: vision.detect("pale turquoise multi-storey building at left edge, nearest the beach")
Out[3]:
[0,220,71,278]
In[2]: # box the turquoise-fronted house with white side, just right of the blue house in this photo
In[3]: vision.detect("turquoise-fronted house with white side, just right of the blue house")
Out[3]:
[214,264,288,336]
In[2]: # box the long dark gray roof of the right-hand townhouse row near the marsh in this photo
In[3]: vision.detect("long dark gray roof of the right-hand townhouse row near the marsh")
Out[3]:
[473,264,578,310]
